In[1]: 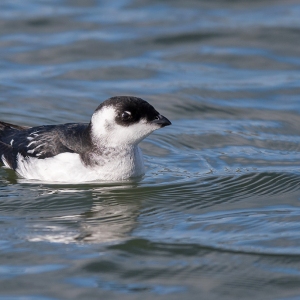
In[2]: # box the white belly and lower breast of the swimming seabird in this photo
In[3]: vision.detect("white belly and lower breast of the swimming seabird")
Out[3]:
[16,147,145,183]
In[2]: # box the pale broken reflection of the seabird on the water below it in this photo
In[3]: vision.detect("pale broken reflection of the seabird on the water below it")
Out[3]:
[16,183,141,244]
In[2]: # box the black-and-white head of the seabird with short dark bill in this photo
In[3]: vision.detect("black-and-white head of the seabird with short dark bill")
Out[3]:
[91,96,171,147]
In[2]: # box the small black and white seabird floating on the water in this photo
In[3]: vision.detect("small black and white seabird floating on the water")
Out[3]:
[0,96,171,183]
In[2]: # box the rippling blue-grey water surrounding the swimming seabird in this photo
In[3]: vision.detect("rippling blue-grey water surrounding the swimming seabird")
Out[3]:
[0,0,300,300]
